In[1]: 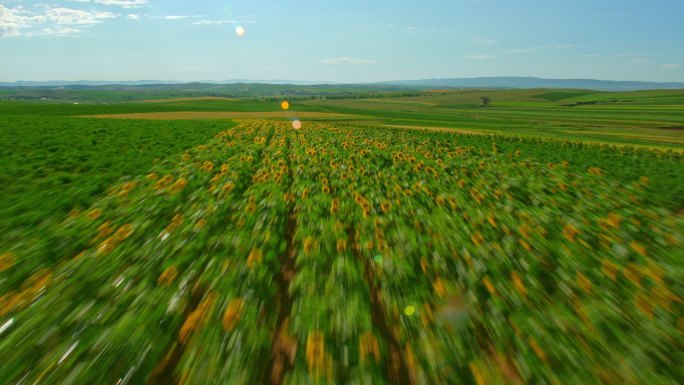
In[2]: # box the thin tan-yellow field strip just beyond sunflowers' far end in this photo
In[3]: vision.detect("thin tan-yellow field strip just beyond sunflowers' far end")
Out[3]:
[80,111,361,120]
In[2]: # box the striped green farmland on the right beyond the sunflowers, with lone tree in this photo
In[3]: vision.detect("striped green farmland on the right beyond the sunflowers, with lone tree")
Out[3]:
[303,90,684,149]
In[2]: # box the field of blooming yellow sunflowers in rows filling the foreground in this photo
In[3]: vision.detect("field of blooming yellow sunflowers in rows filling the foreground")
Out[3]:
[0,121,684,385]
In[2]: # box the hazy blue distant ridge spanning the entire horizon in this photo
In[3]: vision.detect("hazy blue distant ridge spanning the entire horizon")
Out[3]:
[0,76,684,91]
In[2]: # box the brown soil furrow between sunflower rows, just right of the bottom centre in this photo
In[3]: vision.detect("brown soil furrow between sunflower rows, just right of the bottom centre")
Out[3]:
[347,227,413,385]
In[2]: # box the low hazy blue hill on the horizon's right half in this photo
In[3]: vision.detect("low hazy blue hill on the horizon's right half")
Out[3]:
[379,77,684,91]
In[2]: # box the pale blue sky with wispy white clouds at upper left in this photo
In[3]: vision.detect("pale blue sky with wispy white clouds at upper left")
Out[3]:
[0,0,684,82]
